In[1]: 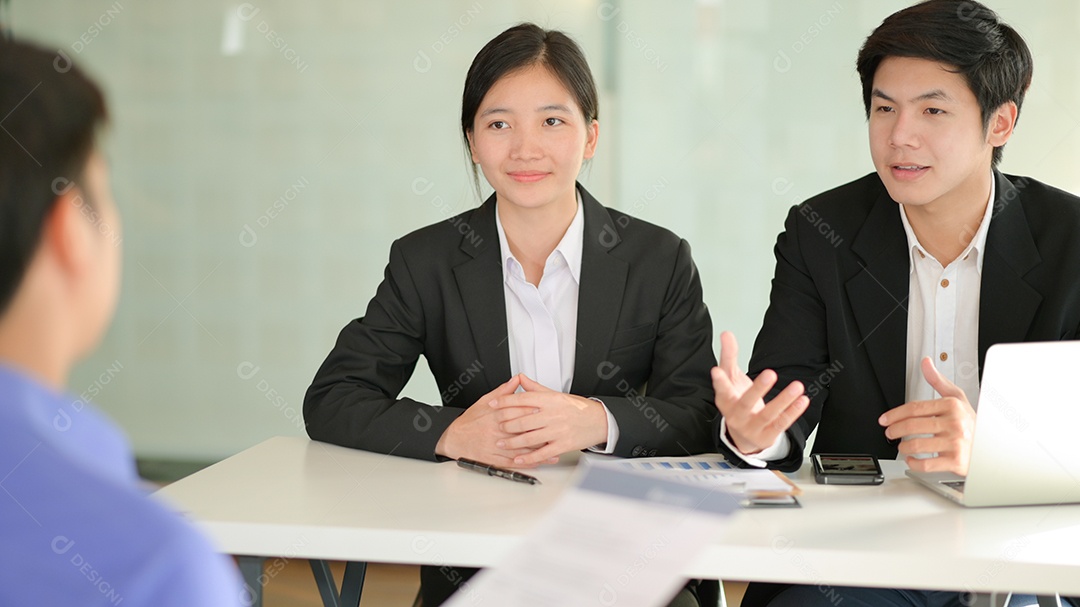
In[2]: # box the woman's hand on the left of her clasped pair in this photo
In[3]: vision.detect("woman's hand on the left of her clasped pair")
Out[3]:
[435,375,542,468]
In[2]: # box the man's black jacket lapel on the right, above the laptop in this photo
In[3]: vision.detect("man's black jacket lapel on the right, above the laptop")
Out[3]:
[978,171,1042,377]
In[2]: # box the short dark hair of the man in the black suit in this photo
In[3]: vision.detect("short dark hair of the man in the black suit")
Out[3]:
[855,0,1032,166]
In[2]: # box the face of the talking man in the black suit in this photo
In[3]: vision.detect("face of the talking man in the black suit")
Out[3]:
[869,57,1008,208]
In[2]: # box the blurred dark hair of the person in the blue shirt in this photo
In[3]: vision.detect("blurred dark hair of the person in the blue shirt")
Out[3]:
[0,39,106,313]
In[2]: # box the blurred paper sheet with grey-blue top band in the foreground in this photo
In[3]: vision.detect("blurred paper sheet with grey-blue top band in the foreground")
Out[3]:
[446,467,739,607]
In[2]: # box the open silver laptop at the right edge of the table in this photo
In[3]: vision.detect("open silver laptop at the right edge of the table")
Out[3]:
[907,341,1080,507]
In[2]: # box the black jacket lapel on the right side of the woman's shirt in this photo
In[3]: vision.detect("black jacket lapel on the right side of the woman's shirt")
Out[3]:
[570,185,629,394]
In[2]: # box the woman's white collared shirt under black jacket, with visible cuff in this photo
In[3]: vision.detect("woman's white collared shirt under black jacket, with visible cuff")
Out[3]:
[495,194,619,454]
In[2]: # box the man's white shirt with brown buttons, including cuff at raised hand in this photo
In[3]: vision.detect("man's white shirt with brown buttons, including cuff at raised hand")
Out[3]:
[719,173,997,468]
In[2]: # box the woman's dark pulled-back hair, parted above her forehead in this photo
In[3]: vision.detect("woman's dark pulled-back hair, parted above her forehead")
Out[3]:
[461,23,599,192]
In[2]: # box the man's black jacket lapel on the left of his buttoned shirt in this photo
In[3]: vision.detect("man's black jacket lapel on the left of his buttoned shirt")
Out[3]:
[846,191,910,407]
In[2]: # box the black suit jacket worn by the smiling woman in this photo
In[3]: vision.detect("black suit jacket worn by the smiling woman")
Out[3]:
[303,186,716,460]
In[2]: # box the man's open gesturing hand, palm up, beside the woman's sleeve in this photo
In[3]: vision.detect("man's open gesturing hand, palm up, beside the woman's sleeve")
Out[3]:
[713,331,810,455]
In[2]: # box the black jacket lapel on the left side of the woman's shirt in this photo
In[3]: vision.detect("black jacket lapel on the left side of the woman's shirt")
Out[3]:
[454,194,510,386]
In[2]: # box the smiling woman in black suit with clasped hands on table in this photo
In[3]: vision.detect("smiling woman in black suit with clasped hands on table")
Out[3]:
[303,24,716,606]
